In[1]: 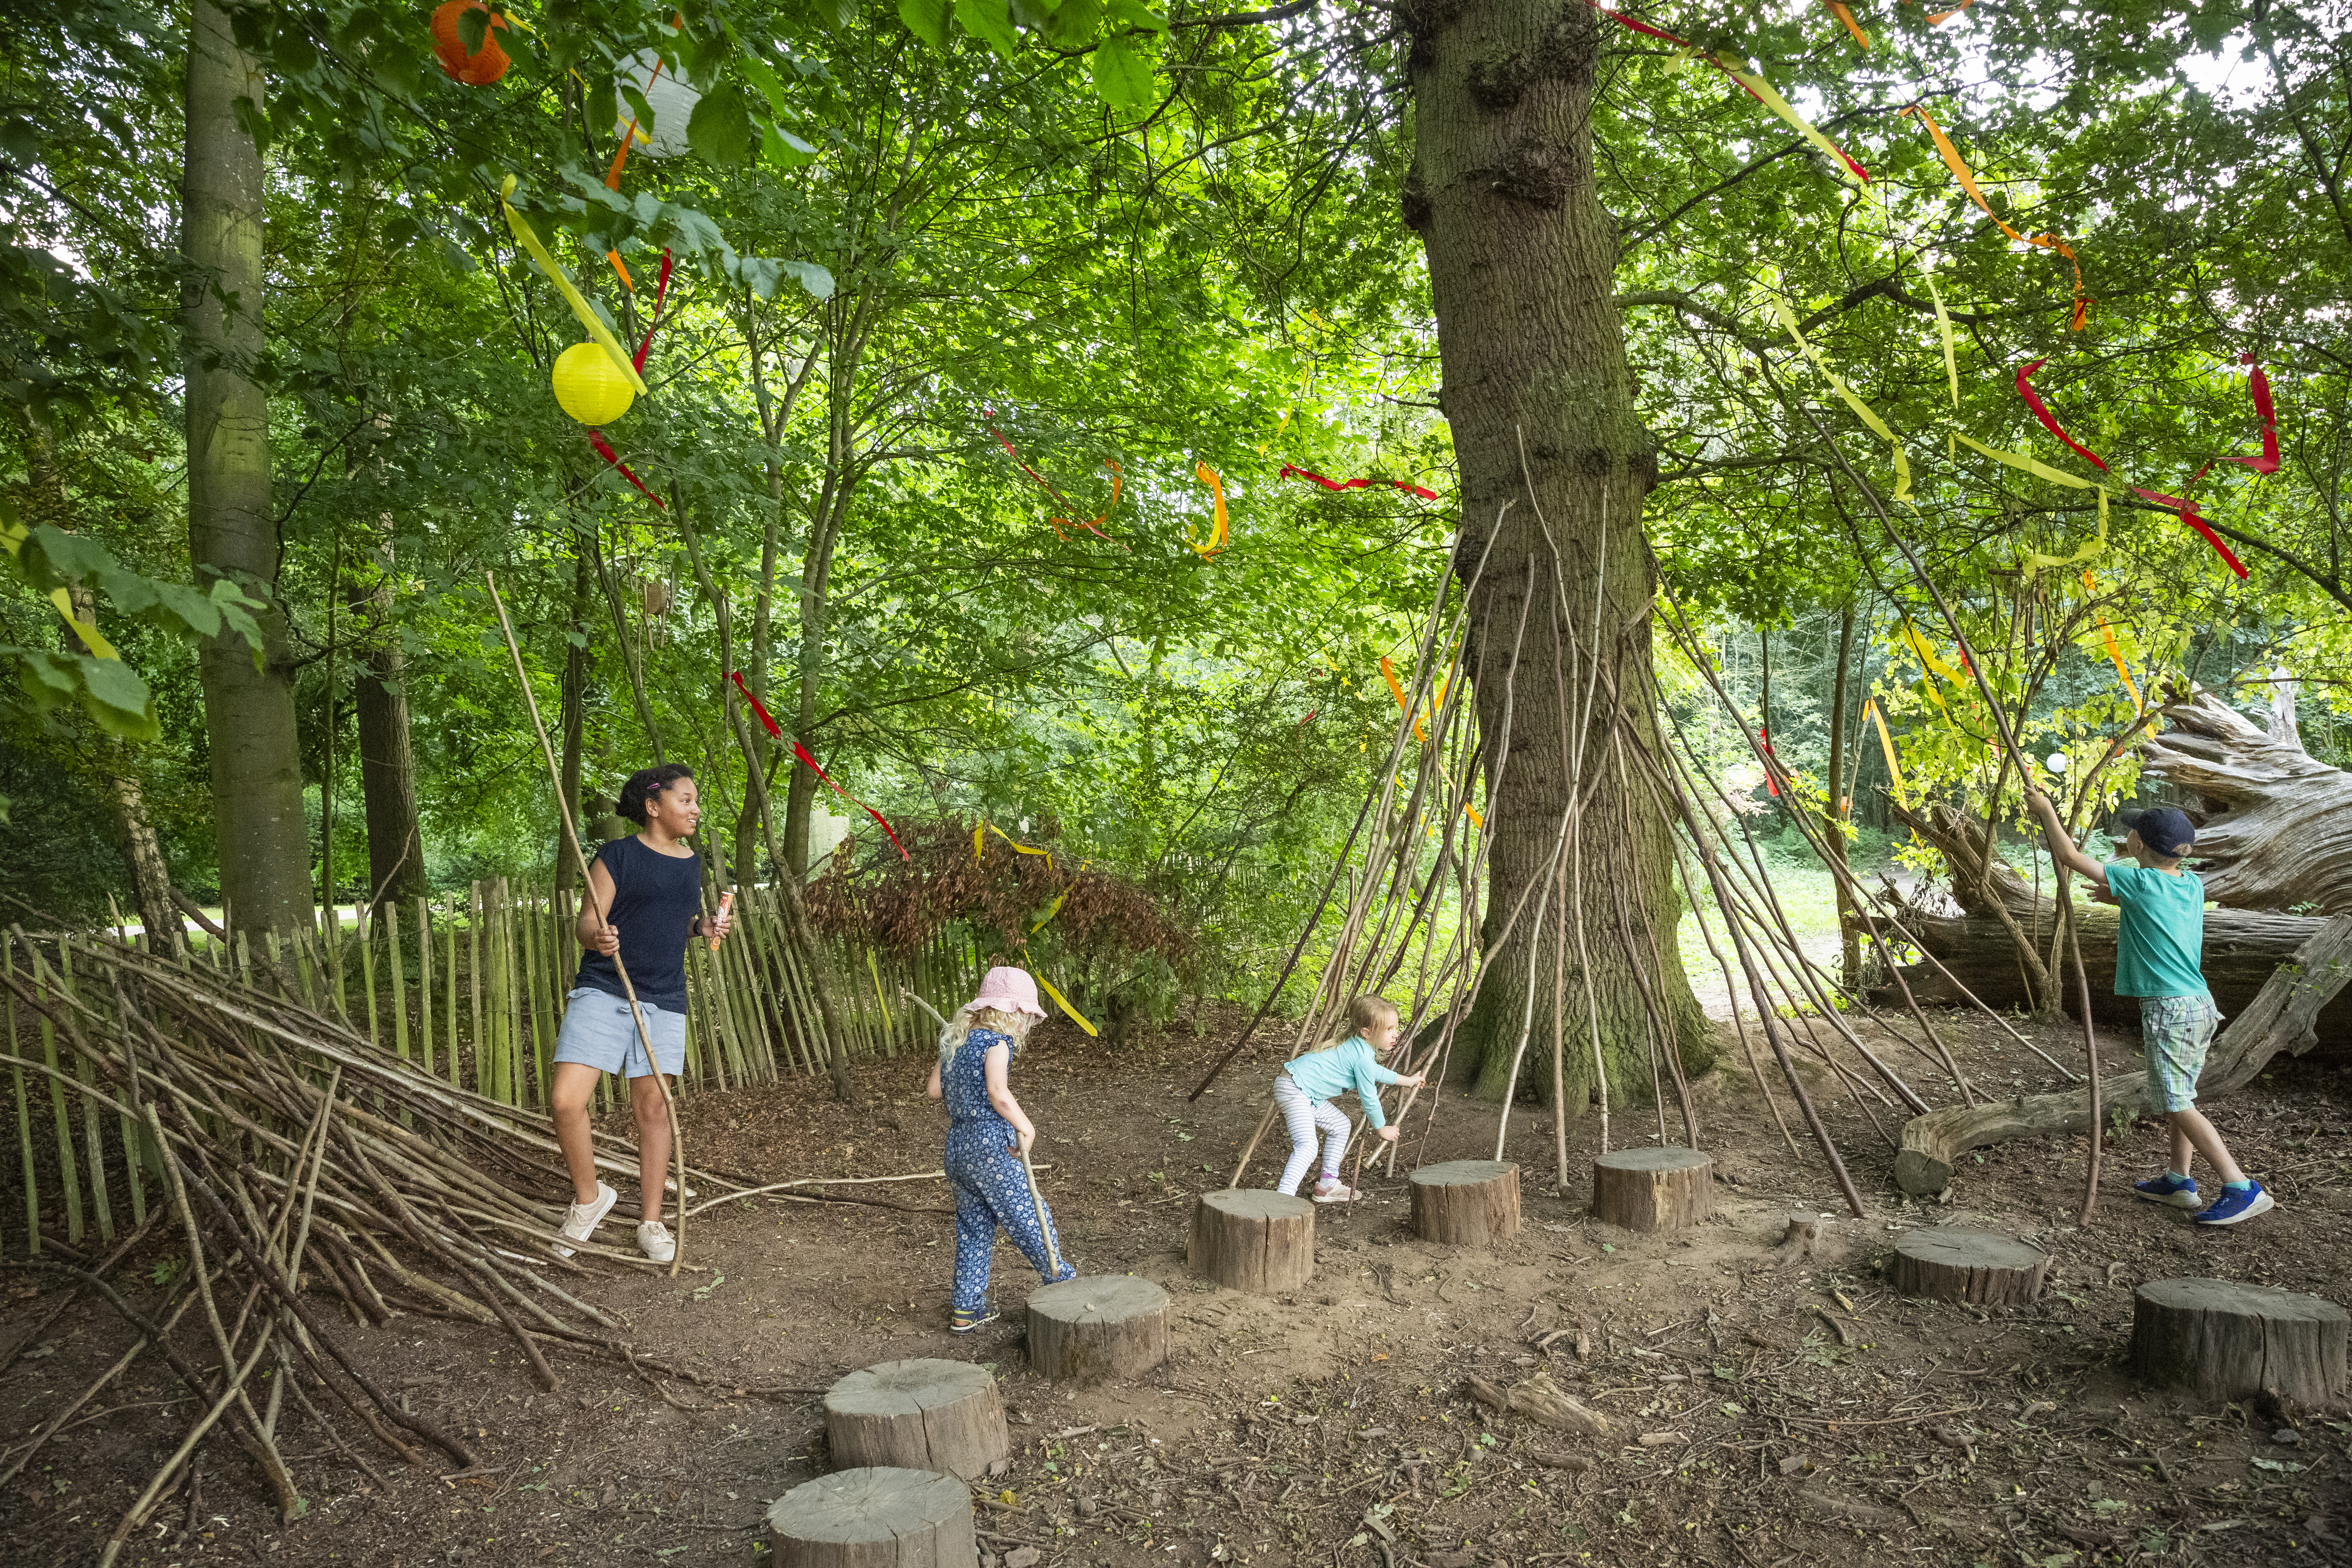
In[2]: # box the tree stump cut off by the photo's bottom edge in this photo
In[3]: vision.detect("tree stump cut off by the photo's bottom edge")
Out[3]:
[767,1465,981,1568]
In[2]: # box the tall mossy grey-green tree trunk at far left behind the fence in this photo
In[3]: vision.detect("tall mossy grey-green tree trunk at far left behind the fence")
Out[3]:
[181,0,310,931]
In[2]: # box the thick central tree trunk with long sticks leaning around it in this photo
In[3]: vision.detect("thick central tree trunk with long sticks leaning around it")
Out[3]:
[1404,0,1712,1107]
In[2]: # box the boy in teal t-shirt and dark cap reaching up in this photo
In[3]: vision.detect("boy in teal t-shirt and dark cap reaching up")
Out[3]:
[2025,790,2277,1225]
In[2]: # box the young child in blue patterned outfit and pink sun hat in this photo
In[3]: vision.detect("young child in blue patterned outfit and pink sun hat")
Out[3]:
[924,964,1077,1333]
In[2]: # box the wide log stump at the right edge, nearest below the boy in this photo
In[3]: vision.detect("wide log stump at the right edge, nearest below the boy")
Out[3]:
[2131,1279,2352,1406]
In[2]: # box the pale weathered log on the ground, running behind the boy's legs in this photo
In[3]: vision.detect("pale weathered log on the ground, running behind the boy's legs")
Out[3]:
[1896,915,2352,1196]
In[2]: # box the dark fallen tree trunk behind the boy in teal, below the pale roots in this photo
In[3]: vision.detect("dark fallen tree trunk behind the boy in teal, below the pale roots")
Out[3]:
[1877,804,2352,1049]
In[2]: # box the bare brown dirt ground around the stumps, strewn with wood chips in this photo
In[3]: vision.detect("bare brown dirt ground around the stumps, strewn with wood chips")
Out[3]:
[0,1009,2352,1568]
